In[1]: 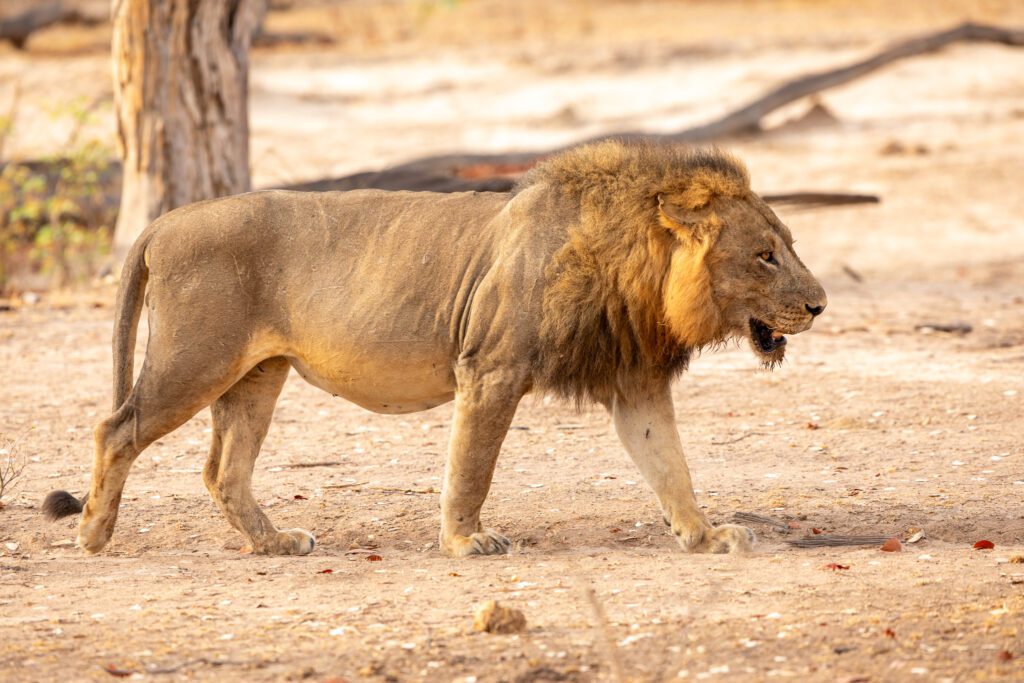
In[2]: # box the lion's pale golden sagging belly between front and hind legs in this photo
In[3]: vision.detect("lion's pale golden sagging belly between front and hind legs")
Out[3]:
[291,348,455,414]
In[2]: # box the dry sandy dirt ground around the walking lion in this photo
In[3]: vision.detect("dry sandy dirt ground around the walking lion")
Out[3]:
[0,2,1024,683]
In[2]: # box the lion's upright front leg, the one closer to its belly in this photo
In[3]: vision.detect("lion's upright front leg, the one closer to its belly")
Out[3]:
[440,368,523,557]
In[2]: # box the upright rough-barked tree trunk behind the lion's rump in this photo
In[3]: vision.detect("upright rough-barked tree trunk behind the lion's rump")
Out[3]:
[113,0,266,261]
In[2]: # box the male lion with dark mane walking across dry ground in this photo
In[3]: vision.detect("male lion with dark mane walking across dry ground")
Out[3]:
[44,140,826,557]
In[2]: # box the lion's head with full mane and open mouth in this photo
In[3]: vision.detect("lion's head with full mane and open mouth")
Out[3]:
[516,140,826,400]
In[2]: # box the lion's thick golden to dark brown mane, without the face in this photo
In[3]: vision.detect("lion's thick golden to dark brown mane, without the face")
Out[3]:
[513,140,749,402]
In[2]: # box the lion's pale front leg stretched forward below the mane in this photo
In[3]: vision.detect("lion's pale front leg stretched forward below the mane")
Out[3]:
[611,380,754,553]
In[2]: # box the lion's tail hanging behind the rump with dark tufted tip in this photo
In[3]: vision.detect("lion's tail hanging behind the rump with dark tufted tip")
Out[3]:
[42,225,154,520]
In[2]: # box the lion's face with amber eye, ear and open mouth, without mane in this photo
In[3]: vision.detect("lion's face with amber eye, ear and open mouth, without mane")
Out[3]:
[663,195,827,366]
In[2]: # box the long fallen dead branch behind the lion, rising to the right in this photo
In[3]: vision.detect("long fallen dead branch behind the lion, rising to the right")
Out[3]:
[288,24,1024,200]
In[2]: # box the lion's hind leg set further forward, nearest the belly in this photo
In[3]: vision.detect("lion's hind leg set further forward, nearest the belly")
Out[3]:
[203,357,315,555]
